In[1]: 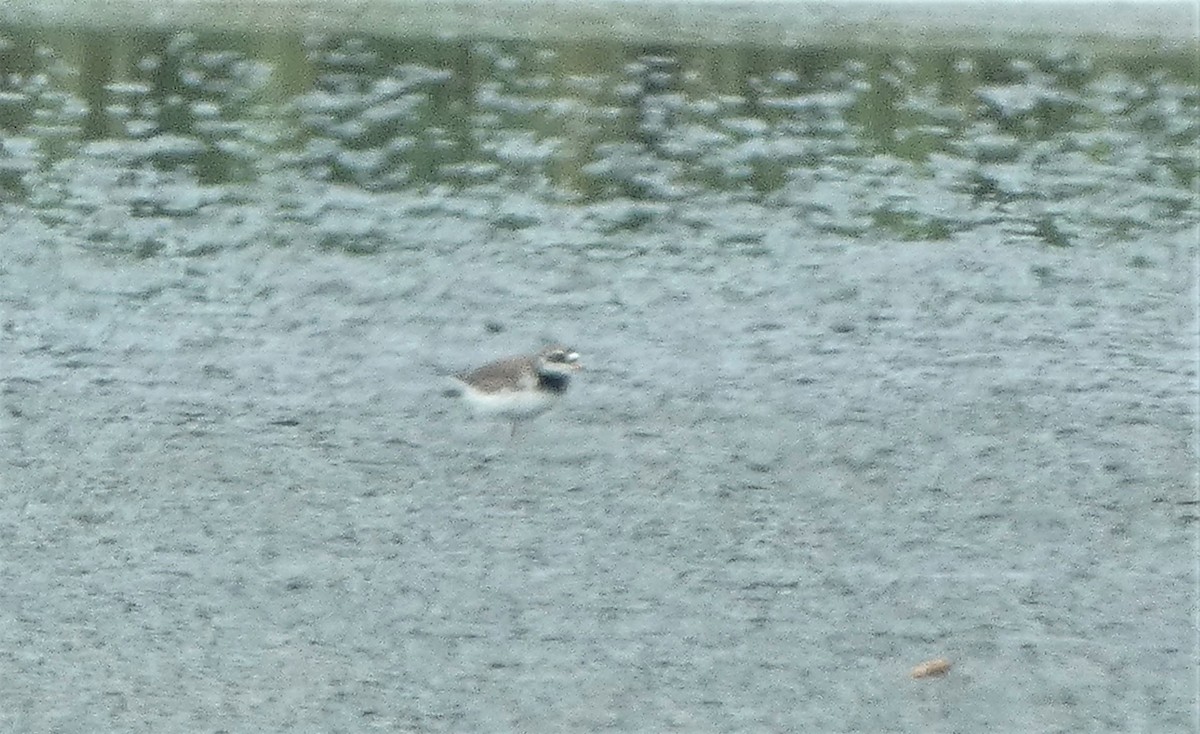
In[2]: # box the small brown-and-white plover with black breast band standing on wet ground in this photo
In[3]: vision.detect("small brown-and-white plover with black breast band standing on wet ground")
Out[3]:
[455,345,582,435]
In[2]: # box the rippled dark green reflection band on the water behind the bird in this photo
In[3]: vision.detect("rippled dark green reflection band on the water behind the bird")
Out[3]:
[0,18,1200,243]
